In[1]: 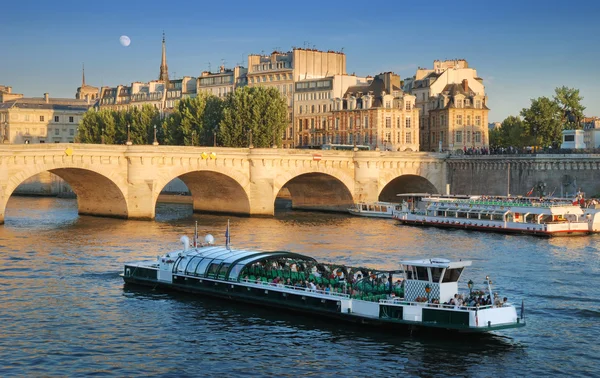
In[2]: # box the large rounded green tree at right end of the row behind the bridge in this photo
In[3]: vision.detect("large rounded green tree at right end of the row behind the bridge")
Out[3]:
[219,87,287,148]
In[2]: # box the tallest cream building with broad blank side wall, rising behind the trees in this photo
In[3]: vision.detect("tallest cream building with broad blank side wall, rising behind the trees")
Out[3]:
[247,48,346,148]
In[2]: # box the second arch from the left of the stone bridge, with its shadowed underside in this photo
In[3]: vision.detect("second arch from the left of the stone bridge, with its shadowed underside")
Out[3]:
[153,166,251,215]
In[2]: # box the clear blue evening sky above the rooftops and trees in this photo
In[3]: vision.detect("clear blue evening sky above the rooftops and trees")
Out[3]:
[0,0,600,122]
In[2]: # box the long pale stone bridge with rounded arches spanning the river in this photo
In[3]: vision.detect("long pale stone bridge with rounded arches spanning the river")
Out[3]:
[0,144,447,224]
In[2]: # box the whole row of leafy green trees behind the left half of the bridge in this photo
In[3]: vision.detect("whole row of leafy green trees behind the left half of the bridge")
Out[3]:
[78,87,287,147]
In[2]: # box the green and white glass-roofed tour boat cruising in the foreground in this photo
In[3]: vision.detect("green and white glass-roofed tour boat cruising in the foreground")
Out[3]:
[121,224,525,333]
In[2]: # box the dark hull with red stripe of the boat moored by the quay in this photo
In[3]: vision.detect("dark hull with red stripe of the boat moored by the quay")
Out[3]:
[395,218,590,237]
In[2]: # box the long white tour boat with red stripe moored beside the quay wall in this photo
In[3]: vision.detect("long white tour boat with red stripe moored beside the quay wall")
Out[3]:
[393,193,600,236]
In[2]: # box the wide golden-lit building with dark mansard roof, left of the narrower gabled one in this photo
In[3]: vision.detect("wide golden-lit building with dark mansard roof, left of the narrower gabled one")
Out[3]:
[326,72,419,151]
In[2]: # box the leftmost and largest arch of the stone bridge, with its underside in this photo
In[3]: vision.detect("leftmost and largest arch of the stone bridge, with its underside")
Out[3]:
[2,163,129,218]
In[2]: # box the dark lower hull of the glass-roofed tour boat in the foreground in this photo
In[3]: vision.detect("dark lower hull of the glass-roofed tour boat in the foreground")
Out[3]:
[123,275,525,335]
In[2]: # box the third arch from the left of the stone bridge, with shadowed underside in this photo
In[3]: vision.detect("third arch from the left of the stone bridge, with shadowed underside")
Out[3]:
[274,172,354,211]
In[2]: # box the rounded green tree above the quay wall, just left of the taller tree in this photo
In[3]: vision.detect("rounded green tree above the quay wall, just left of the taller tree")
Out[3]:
[521,97,562,148]
